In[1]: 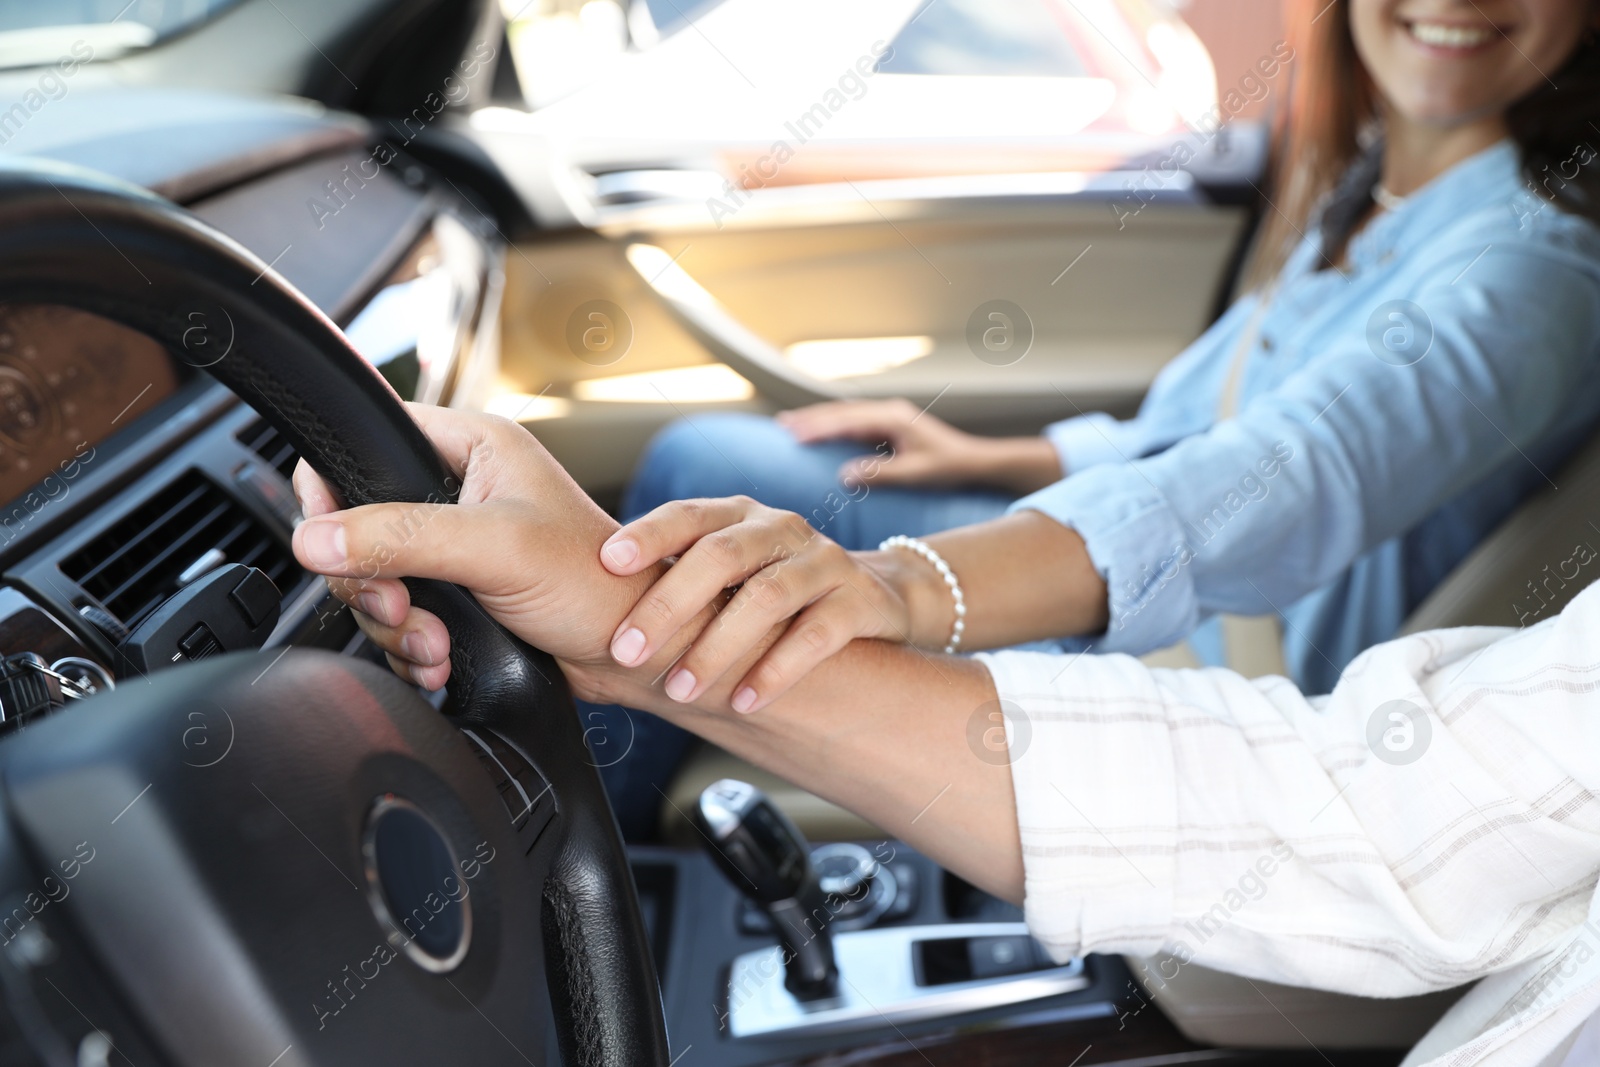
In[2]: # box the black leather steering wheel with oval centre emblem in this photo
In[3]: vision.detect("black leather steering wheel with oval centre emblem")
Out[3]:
[0,162,667,1067]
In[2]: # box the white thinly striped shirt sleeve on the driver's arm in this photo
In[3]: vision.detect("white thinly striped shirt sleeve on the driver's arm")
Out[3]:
[981,585,1600,1004]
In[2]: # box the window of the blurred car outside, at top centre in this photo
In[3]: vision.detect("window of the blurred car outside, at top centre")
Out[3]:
[876,0,1085,78]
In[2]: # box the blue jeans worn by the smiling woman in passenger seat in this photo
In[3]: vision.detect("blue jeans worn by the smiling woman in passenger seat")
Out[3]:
[579,414,1011,840]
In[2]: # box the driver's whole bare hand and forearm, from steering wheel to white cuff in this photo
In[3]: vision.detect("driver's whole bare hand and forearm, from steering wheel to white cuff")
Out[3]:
[294,405,1024,901]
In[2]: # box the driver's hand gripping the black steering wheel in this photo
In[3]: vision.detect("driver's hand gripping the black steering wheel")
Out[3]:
[294,405,654,689]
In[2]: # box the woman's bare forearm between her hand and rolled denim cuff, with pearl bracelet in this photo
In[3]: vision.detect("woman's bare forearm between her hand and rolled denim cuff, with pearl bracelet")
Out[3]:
[861,510,1109,651]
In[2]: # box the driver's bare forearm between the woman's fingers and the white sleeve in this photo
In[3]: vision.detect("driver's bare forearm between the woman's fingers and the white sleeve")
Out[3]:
[562,609,1022,902]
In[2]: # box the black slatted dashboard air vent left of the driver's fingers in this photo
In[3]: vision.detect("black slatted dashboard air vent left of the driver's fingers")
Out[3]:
[61,470,306,629]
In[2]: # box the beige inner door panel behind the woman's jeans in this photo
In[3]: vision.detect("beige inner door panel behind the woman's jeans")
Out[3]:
[502,174,1248,494]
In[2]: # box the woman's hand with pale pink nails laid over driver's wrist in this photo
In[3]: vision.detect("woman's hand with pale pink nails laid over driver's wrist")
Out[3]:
[600,496,928,712]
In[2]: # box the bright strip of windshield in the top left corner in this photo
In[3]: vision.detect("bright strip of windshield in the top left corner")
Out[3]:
[0,0,238,67]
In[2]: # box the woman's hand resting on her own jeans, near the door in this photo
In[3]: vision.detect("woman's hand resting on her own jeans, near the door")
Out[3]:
[778,400,1061,493]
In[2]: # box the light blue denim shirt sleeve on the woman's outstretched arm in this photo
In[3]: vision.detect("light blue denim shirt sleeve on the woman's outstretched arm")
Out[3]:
[1013,245,1600,653]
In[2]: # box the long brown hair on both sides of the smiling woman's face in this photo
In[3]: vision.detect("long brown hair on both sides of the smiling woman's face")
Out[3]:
[1245,0,1600,290]
